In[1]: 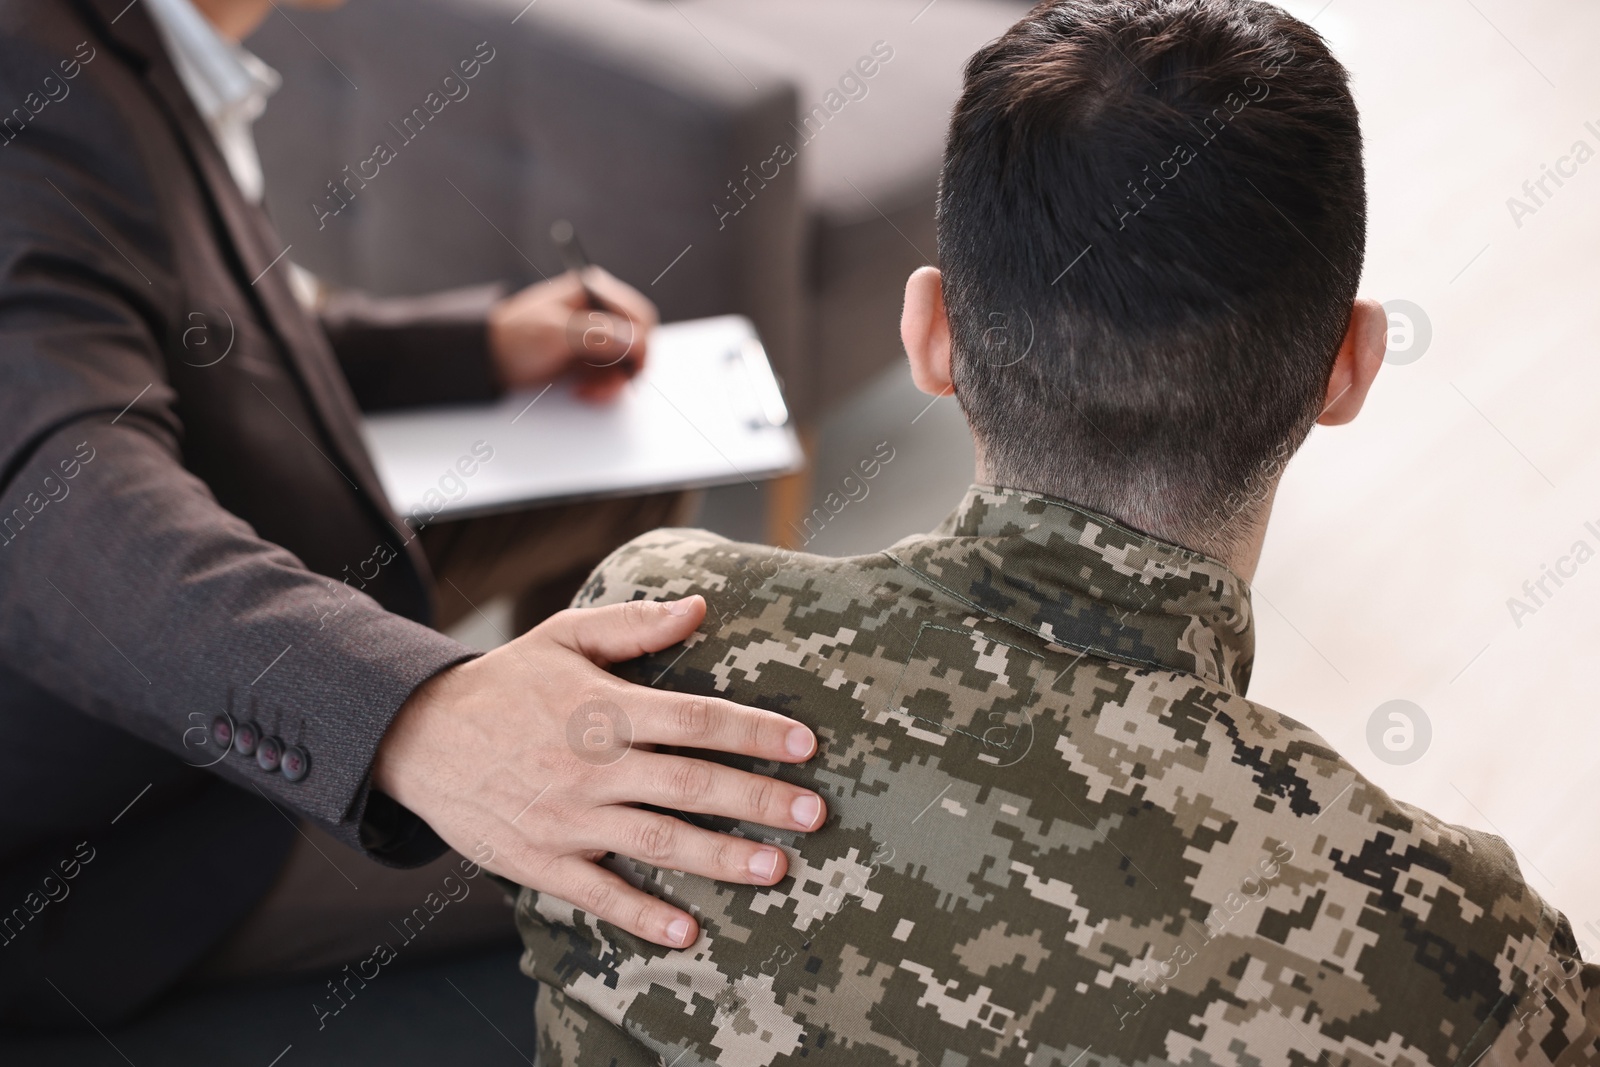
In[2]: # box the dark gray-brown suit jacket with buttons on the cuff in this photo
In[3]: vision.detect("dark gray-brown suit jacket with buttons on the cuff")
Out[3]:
[0,0,493,1025]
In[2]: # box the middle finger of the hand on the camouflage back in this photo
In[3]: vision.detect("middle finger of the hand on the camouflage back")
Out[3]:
[620,752,827,831]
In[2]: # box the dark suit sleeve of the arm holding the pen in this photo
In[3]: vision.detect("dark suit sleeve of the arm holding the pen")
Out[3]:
[320,285,504,411]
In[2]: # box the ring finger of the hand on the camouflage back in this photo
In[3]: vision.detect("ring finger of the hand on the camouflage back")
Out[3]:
[594,806,789,886]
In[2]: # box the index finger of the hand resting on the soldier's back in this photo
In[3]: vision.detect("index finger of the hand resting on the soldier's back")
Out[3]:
[618,686,816,763]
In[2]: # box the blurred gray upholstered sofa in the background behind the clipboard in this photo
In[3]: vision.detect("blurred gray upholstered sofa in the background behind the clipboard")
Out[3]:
[251,0,1026,422]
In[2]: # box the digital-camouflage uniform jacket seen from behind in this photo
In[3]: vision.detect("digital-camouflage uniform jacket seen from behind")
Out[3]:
[517,486,1600,1067]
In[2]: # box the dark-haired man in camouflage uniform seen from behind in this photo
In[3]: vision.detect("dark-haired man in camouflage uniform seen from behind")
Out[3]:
[517,0,1600,1067]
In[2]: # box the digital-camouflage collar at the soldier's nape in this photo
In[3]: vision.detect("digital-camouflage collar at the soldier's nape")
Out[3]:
[886,485,1256,694]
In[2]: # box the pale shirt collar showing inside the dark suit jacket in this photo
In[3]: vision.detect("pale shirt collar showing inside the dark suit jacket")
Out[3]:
[144,0,282,202]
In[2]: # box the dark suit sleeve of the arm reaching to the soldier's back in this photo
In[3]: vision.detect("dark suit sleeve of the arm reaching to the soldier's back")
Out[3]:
[0,48,474,862]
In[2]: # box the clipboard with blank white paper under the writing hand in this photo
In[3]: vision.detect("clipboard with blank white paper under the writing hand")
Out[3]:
[362,315,805,525]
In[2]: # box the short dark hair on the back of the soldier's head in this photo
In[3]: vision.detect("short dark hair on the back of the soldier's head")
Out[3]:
[939,0,1366,549]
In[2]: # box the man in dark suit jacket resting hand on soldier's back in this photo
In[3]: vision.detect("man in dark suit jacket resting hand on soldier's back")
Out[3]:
[0,0,822,1025]
